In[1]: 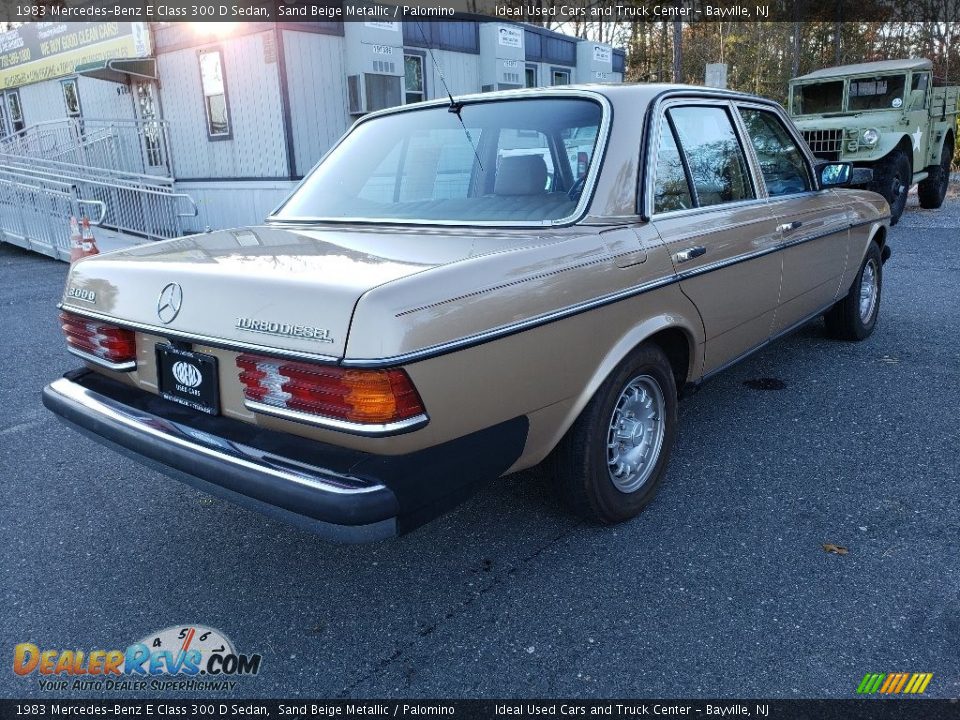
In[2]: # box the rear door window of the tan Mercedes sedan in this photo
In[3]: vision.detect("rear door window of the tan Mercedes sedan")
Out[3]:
[667,106,756,207]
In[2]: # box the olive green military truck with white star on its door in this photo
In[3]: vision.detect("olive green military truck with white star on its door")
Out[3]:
[789,59,960,223]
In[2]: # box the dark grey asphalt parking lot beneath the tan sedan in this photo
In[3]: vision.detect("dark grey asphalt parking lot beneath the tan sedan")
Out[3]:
[0,192,960,698]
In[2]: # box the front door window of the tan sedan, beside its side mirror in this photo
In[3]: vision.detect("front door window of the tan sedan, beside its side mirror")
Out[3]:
[740,108,813,196]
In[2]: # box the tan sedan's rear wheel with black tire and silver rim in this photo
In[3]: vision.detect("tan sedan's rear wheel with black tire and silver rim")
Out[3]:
[551,343,677,525]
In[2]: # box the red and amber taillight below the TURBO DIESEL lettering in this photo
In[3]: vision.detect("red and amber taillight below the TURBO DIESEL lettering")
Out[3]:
[237,355,424,425]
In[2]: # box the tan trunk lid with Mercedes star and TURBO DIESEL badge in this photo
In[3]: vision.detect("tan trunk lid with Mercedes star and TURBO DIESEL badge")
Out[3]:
[63,226,552,358]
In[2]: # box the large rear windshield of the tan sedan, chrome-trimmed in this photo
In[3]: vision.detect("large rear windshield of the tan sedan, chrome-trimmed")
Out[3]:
[272,98,603,224]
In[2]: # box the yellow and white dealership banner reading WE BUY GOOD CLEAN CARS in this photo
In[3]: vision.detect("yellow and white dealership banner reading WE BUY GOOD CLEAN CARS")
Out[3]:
[0,22,150,90]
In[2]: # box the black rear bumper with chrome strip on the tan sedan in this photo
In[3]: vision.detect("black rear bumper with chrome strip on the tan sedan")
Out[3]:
[43,370,527,542]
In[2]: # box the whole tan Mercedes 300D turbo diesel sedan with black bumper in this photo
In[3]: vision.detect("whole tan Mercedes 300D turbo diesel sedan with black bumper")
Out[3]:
[44,85,889,540]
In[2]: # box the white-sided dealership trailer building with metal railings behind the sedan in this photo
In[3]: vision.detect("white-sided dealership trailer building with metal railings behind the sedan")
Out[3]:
[0,16,624,257]
